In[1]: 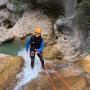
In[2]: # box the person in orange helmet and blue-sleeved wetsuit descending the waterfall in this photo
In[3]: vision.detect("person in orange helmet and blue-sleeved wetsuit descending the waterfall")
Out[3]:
[26,27,45,69]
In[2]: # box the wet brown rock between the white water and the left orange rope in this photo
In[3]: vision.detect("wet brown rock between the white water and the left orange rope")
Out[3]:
[24,74,52,90]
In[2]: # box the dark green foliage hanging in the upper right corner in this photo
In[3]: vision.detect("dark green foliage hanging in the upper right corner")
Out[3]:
[78,0,90,29]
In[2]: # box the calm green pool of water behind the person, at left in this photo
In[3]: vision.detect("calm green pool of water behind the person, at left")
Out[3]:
[0,38,25,56]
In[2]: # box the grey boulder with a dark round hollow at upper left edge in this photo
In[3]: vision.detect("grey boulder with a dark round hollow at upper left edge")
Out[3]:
[0,8,19,28]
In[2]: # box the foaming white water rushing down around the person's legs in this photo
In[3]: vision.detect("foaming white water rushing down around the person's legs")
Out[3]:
[14,49,41,90]
